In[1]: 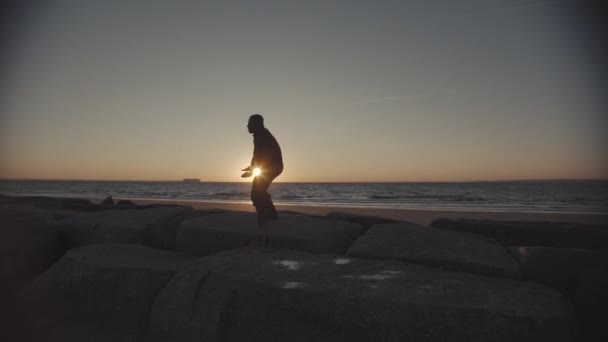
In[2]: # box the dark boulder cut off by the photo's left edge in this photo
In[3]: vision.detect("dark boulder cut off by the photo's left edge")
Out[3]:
[0,209,63,295]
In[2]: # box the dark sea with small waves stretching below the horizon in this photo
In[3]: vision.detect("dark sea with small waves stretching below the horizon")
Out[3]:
[0,180,608,214]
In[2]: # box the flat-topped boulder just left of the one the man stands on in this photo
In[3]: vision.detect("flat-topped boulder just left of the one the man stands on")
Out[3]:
[58,206,193,249]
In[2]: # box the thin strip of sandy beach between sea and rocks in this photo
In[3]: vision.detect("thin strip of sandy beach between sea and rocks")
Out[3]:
[87,198,608,226]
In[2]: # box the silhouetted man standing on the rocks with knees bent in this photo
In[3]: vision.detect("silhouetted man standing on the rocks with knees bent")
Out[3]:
[241,114,283,226]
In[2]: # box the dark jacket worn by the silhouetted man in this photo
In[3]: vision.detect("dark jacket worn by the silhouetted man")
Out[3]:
[251,128,283,174]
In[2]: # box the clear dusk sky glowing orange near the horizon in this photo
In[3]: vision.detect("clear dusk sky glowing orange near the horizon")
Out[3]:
[0,0,608,181]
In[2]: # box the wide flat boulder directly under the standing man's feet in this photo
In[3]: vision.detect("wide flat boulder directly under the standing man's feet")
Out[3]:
[177,212,362,256]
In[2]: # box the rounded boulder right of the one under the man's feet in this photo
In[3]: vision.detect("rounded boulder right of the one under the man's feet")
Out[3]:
[347,222,520,278]
